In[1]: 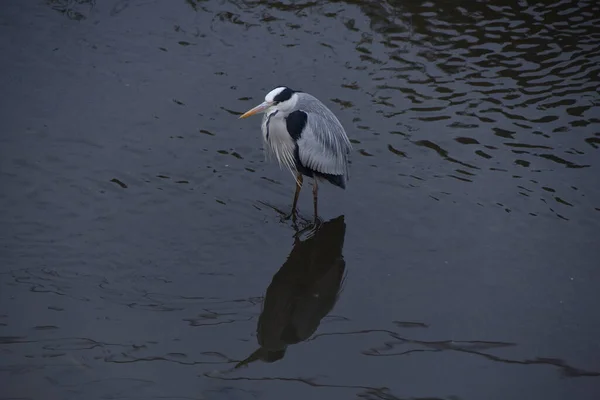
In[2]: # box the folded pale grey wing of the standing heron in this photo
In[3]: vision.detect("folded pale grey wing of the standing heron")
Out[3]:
[297,106,352,177]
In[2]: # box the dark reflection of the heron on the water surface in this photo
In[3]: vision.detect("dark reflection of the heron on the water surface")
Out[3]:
[235,215,346,368]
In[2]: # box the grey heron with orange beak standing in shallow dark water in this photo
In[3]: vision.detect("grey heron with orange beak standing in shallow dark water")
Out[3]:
[240,86,352,222]
